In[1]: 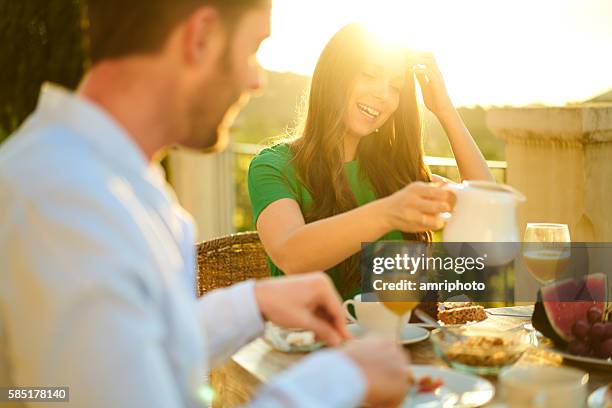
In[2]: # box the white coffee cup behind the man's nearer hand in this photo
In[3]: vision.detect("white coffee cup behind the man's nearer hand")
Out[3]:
[343,295,410,339]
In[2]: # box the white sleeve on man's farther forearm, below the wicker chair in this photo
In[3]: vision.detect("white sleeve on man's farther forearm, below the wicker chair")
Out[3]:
[197,281,264,367]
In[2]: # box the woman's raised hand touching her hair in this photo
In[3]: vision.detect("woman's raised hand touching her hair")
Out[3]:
[408,52,455,119]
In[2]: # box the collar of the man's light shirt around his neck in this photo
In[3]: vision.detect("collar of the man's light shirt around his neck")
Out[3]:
[37,83,160,178]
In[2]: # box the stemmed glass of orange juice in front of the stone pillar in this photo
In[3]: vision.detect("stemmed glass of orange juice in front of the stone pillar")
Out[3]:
[523,223,571,284]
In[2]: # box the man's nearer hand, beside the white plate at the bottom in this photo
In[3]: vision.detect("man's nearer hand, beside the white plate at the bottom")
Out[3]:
[341,337,414,407]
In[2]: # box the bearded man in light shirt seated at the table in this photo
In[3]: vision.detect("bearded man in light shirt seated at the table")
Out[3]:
[0,0,411,408]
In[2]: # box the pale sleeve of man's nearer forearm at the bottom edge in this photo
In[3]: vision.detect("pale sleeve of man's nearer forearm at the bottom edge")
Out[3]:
[247,350,366,408]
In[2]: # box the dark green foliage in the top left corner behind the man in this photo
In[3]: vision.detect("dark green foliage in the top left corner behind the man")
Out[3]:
[0,0,85,141]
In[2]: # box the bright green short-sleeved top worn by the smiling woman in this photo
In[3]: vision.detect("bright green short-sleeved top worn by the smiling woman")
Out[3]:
[248,143,403,298]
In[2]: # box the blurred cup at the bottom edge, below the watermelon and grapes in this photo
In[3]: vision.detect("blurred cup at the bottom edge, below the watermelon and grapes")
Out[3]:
[499,366,589,408]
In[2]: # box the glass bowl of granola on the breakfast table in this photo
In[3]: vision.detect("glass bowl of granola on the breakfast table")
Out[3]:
[431,326,531,375]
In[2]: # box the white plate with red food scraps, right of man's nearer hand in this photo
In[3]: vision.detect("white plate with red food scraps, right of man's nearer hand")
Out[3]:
[401,365,495,408]
